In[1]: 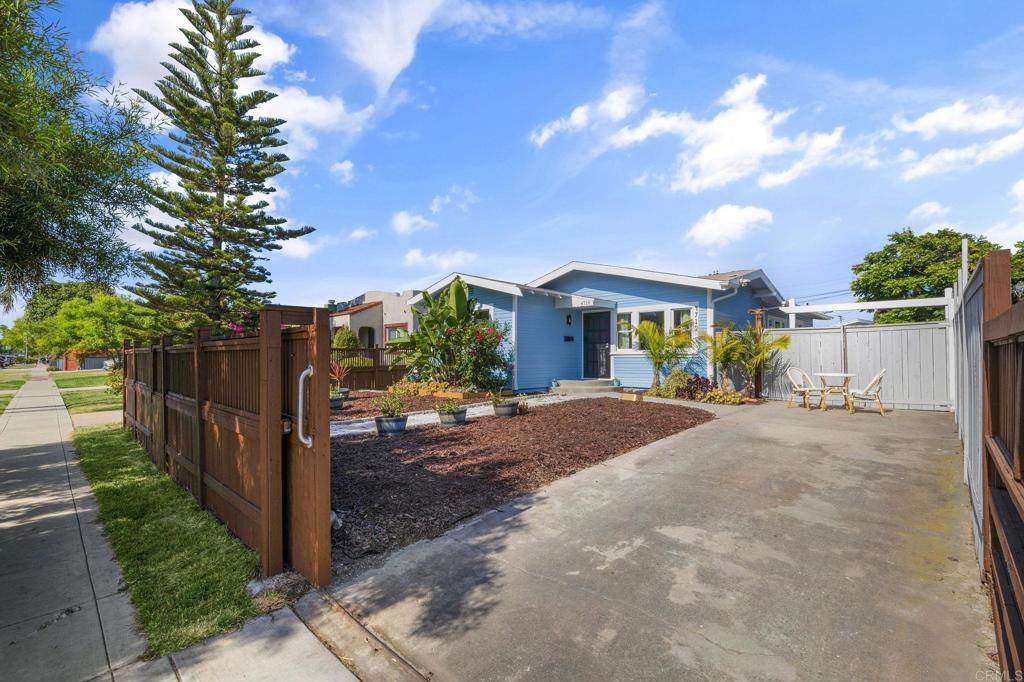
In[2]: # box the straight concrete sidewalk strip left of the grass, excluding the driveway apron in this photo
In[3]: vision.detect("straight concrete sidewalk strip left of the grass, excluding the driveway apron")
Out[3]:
[0,368,145,680]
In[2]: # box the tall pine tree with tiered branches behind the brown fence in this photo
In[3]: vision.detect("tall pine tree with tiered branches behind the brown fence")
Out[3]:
[131,0,313,331]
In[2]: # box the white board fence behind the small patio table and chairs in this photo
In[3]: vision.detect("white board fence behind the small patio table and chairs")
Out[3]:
[764,322,951,411]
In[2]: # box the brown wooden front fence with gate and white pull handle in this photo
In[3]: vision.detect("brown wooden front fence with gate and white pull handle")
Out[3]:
[124,305,331,585]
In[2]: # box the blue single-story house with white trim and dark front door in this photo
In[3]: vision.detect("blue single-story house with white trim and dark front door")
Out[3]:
[410,261,821,391]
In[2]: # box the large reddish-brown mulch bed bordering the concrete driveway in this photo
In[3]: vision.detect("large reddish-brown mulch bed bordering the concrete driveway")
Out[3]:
[331,398,715,562]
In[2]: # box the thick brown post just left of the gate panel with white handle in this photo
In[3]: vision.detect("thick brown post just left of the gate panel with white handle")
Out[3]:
[259,306,284,576]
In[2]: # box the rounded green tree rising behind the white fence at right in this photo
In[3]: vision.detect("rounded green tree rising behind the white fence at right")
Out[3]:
[850,229,999,324]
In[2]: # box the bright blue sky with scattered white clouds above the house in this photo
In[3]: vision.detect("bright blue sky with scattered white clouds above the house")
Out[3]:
[14,0,1024,321]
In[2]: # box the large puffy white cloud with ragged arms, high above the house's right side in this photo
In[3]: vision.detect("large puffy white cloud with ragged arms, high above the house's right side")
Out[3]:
[609,74,844,194]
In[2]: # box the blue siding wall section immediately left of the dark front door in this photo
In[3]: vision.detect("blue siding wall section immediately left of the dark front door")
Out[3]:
[516,294,583,390]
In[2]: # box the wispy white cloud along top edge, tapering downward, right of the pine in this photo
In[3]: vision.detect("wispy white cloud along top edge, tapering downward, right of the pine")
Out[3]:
[278,0,606,94]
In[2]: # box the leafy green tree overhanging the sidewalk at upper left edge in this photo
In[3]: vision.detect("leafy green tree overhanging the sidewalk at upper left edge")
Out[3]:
[0,0,148,309]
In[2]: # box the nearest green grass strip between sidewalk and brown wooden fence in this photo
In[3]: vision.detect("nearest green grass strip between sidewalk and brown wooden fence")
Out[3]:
[74,426,259,656]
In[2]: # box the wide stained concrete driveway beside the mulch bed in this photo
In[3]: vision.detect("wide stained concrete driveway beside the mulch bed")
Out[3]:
[331,404,994,682]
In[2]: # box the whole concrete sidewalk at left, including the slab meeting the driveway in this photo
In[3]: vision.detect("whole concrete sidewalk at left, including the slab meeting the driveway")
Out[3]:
[0,369,356,682]
